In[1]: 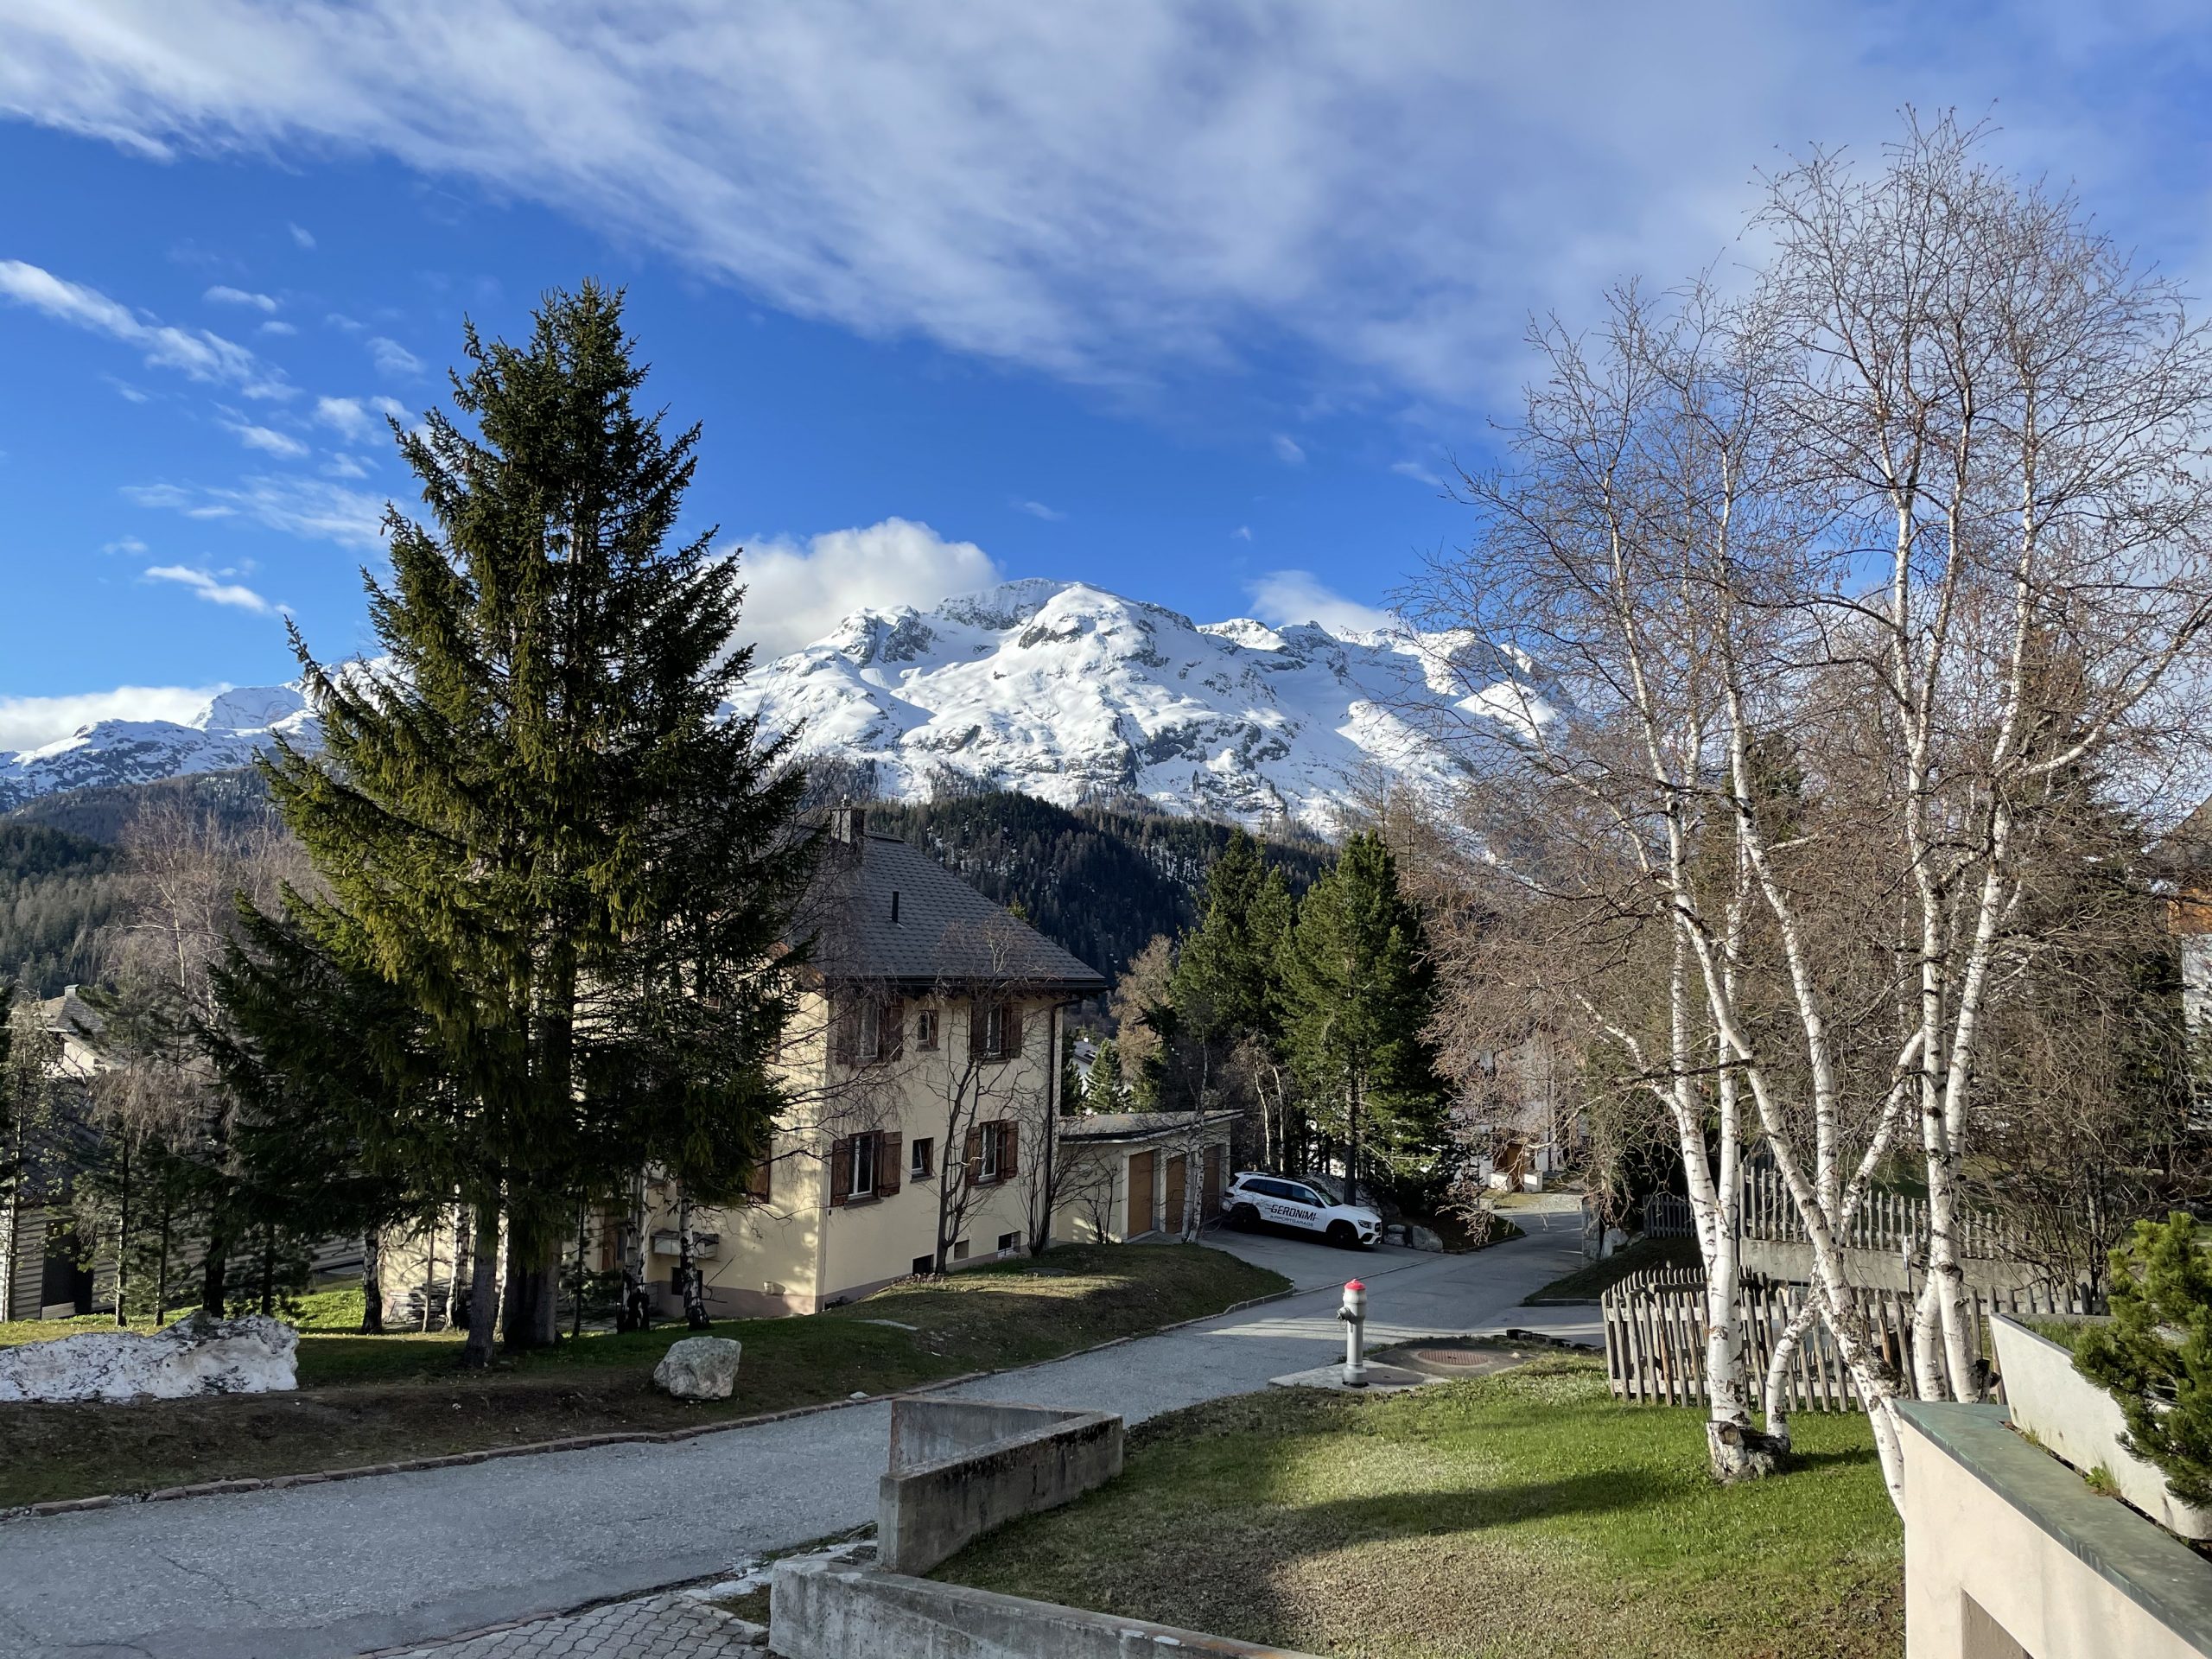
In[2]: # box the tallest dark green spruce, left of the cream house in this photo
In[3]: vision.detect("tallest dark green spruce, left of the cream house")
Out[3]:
[264,283,812,1363]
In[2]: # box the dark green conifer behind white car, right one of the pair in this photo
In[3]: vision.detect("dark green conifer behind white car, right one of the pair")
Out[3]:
[1279,834,1445,1181]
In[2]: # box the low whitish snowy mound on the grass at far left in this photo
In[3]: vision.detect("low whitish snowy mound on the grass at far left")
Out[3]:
[0,1314,299,1400]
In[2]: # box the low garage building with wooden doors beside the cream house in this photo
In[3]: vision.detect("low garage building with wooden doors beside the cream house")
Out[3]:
[1053,1113,1239,1243]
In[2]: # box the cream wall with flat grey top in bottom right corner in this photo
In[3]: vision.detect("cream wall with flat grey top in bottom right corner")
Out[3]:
[1897,1400,2212,1659]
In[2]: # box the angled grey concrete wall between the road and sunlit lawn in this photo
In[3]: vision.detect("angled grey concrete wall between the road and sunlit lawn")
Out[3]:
[876,1400,1122,1573]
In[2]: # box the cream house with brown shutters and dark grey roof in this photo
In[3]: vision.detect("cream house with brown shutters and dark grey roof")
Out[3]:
[641,807,1106,1319]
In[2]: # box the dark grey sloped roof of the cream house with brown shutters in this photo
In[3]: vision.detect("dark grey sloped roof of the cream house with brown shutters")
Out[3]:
[803,807,1106,995]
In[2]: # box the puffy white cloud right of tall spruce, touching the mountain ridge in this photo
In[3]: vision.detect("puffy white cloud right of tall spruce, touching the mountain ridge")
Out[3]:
[739,518,1000,661]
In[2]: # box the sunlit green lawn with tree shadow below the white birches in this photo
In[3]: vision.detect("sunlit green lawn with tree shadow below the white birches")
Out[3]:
[938,1358,1904,1659]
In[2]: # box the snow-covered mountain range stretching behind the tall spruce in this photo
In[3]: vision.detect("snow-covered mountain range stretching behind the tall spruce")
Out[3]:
[0,580,1522,832]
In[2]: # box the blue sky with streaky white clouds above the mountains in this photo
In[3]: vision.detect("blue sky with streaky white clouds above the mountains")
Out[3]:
[0,0,2212,750]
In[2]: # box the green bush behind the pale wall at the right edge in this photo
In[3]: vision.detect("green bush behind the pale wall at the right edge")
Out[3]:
[2075,1212,2212,1506]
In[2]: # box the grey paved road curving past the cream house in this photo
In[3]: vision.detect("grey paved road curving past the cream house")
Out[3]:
[0,1212,1580,1659]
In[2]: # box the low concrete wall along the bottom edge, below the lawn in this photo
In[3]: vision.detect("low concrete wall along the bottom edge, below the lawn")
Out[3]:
[767,1561,1310,1659]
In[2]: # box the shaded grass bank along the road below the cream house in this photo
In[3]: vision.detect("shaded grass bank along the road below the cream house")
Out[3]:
[0,1245,1287,1509]
